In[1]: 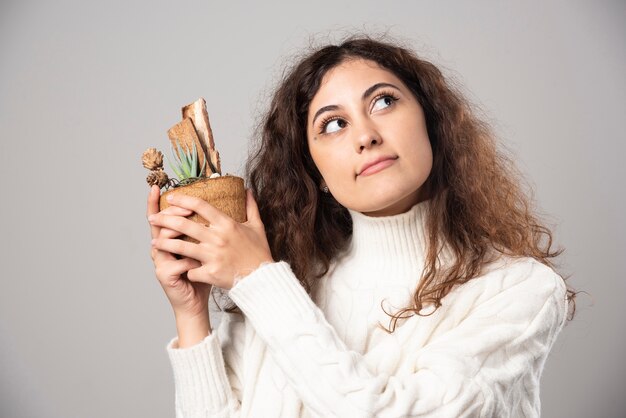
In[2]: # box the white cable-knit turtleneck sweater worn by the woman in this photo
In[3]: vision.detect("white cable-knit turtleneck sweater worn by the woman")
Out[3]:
[167,201,567,418]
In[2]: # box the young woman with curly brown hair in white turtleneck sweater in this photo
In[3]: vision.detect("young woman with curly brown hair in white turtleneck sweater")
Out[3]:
[148,38,574,417]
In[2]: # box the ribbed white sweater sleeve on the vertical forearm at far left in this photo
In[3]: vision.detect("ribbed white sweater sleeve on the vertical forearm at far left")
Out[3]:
[166,312,245,418]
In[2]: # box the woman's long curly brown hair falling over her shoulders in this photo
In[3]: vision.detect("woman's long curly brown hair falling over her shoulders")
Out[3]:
[216,36,576,332]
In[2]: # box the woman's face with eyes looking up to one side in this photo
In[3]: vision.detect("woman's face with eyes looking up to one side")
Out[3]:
[307,59,433,216]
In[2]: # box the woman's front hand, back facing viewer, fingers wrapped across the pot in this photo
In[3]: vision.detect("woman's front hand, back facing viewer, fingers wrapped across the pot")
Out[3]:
[149,190,274,289]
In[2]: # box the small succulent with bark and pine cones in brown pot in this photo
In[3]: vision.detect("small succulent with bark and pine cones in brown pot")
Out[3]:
[141,98,246,243]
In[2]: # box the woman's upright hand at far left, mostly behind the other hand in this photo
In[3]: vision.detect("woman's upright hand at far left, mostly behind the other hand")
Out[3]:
[146,186,211,322]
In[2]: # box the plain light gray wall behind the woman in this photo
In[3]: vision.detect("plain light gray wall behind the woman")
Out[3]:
[0,0,626,418]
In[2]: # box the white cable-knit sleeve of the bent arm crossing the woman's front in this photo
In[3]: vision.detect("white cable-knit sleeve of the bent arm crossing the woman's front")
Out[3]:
[229,262,566,417]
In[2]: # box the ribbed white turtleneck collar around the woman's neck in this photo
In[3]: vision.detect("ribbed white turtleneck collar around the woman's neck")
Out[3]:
[347,200,430,273]
